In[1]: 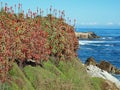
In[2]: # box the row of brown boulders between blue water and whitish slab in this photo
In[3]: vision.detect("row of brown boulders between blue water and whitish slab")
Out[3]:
[85,57,120,74]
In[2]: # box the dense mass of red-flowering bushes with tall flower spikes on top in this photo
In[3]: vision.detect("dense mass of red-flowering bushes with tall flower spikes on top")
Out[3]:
[0,2,78,82]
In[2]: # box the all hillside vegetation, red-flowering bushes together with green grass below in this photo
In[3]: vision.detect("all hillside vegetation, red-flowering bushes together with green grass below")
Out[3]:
[0,3,118,90]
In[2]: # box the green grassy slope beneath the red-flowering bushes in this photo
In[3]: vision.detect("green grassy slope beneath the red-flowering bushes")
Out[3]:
[3,59,103,90]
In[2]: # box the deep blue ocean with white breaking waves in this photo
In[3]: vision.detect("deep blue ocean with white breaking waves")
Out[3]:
[76,28,120,80]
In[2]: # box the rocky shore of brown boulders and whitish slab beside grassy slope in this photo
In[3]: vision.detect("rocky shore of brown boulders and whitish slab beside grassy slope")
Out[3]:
[85,57,120,90]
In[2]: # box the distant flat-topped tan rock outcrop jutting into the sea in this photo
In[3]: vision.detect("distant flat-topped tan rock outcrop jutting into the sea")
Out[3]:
[75,32,99,39]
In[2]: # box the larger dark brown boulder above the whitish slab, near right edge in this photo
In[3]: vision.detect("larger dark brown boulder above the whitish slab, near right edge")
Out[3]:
[98,61,115,73]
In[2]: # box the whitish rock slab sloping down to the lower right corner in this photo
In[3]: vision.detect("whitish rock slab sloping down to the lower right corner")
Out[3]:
[87,65,120,90]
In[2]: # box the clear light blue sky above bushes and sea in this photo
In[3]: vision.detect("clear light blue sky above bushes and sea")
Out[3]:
[0,0,120,28]
